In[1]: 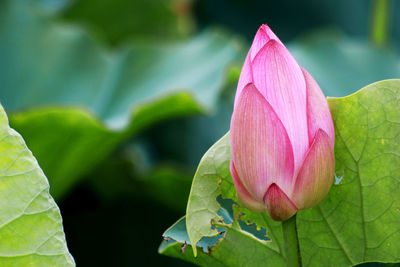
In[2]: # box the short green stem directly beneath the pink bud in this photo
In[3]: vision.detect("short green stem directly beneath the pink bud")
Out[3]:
[282,214,301,267]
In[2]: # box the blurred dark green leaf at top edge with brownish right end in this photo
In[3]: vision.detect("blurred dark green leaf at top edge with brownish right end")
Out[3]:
[63,0,193,45]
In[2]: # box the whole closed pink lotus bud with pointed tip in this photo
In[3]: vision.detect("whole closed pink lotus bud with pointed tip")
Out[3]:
[231,25,335,221]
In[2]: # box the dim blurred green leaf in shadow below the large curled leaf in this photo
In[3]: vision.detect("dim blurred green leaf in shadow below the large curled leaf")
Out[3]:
[86,146,192,214]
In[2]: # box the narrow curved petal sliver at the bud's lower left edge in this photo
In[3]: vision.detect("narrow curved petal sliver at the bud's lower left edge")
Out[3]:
[230,160,265,212]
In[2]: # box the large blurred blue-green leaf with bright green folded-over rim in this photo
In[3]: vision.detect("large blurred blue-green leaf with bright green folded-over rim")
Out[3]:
[0,0,243,198]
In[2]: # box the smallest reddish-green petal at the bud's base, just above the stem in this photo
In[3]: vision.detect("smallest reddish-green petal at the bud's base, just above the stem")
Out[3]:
[264,184,298,221]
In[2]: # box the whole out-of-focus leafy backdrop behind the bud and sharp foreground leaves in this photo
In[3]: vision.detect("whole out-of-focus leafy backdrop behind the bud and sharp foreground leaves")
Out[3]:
[0,0,400,266]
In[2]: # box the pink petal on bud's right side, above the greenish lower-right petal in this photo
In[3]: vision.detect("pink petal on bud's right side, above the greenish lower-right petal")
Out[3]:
[301,68,335,147]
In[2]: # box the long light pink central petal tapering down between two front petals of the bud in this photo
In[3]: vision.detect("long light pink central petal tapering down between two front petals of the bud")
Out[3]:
[252,40,309,170]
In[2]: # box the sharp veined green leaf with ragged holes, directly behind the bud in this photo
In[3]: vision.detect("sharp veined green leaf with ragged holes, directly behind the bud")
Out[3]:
[161,80,400,266]
